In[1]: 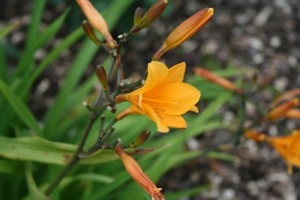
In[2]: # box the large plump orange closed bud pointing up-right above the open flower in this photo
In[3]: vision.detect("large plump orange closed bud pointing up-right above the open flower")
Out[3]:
[152,8,214,60]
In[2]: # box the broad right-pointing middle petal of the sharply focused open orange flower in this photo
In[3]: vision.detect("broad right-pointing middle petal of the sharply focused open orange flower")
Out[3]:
[142,82,200,115]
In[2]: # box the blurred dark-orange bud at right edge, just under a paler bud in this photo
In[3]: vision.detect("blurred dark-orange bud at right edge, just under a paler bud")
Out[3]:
[265,98,299,120]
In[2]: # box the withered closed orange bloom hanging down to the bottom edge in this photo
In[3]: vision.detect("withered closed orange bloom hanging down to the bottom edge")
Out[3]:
[115,146,164,200]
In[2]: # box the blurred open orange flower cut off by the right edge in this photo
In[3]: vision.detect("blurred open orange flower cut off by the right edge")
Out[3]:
[245,130,300,174]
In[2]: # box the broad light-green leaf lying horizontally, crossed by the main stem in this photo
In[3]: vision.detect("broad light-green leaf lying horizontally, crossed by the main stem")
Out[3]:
[0,136,119,165]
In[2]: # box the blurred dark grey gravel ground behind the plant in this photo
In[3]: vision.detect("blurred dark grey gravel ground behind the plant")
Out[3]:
[0,0,300,200]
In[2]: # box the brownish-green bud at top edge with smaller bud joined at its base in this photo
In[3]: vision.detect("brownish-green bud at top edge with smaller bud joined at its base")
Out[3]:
[130,0,168,34]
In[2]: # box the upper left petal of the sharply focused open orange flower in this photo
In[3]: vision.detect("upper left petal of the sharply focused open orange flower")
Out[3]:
[143,61,168,92]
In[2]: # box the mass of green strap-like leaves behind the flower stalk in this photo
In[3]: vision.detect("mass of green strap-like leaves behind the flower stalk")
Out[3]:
[0,0,247,200]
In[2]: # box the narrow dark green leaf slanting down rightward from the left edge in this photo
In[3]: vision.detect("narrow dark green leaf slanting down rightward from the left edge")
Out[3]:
[0,79,42,135]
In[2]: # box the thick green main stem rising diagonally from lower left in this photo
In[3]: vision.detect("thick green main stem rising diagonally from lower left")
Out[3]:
[45,113,99,196]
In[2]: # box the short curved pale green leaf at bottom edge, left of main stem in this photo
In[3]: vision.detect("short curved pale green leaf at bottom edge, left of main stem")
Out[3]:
[25,163,49,200]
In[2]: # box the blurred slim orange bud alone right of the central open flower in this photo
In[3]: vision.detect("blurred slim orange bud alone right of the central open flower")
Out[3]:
[194,67,242,94]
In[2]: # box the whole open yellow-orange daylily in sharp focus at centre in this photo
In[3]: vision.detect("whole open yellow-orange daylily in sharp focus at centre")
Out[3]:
[116,61,200,132]
